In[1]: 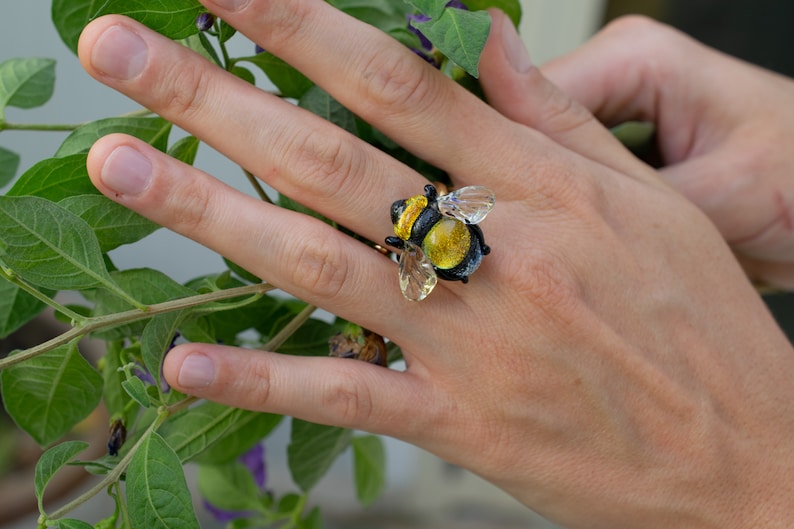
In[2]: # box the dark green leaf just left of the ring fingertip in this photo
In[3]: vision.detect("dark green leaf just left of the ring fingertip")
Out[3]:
[6,154,99,202]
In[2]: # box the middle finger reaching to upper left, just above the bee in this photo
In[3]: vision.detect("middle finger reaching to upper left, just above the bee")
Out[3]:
[79,17,426,240]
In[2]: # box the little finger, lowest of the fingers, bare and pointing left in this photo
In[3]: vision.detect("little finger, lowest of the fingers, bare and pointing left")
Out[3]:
[163,344,442,441]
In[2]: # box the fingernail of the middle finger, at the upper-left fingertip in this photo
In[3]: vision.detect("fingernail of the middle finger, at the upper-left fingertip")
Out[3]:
[91,25,148,81]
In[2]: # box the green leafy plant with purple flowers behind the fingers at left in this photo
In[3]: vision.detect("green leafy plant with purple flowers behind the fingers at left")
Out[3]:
[0,0,520,529]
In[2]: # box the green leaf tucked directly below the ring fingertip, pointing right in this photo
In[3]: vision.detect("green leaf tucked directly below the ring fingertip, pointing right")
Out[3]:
[58,195,160,252]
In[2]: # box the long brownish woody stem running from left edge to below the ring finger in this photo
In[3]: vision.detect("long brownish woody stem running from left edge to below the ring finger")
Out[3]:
[0,283,275,371]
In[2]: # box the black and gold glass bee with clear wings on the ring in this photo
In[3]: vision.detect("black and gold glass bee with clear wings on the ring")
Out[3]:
[386,184,496,301]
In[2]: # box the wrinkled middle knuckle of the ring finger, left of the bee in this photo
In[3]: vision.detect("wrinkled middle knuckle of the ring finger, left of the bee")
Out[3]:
[287,235,348,299]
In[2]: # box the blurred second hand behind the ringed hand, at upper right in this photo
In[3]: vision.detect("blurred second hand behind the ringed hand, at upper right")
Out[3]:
[483,17,794,288]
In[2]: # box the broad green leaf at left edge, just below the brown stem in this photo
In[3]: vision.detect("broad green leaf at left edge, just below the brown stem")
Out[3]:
[0,343,102,446]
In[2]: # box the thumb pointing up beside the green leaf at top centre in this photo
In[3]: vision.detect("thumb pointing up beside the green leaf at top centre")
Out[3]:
[480,9,646,177]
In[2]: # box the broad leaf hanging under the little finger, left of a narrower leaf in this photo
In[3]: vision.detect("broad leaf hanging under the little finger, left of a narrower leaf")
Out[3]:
[287,418,346,492]
